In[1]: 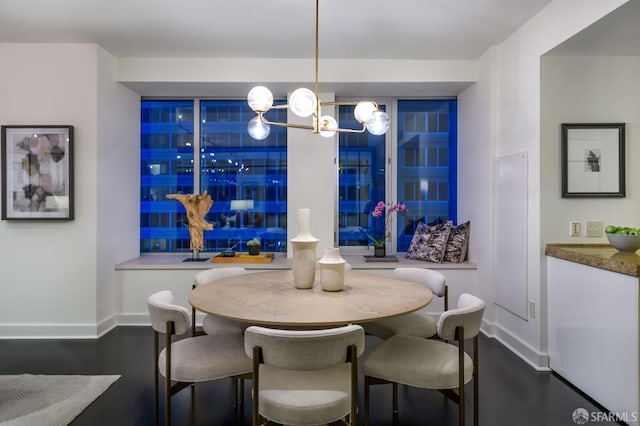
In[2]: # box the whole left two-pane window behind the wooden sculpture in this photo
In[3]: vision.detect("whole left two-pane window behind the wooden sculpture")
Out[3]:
[140,100,287,253]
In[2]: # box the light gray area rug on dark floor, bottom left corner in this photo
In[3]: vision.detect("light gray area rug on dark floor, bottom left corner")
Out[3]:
[0,374,120,426]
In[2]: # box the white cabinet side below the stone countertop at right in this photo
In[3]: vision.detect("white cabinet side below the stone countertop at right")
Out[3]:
[547,257,640,425]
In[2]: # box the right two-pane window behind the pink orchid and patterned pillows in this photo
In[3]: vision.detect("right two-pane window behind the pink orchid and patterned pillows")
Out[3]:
[338,100,457,252]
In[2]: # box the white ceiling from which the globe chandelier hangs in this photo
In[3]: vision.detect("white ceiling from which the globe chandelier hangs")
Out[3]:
[0,0,551,60]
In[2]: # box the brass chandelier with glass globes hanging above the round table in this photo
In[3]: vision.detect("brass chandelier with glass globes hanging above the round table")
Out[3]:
[247,0,389,140]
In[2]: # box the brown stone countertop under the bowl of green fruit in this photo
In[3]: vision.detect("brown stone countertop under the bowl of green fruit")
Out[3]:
[544,243,640,277]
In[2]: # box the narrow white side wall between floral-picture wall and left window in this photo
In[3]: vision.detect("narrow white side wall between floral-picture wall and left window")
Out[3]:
[95,47,140,334]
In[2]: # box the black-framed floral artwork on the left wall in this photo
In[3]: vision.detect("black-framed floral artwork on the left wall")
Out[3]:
[0,125,74,220]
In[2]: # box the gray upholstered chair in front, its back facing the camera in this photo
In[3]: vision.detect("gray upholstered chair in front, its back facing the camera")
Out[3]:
[244,325,364,426]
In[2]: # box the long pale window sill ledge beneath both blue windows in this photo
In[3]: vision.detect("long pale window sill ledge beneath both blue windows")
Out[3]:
[115,253,477,271]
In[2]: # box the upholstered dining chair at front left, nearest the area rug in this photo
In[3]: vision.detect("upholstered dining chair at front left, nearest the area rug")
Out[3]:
[147,290,252,425]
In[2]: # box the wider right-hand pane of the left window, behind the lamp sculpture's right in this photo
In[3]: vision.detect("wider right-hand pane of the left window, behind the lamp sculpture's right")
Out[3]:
[200,101,287,251]
